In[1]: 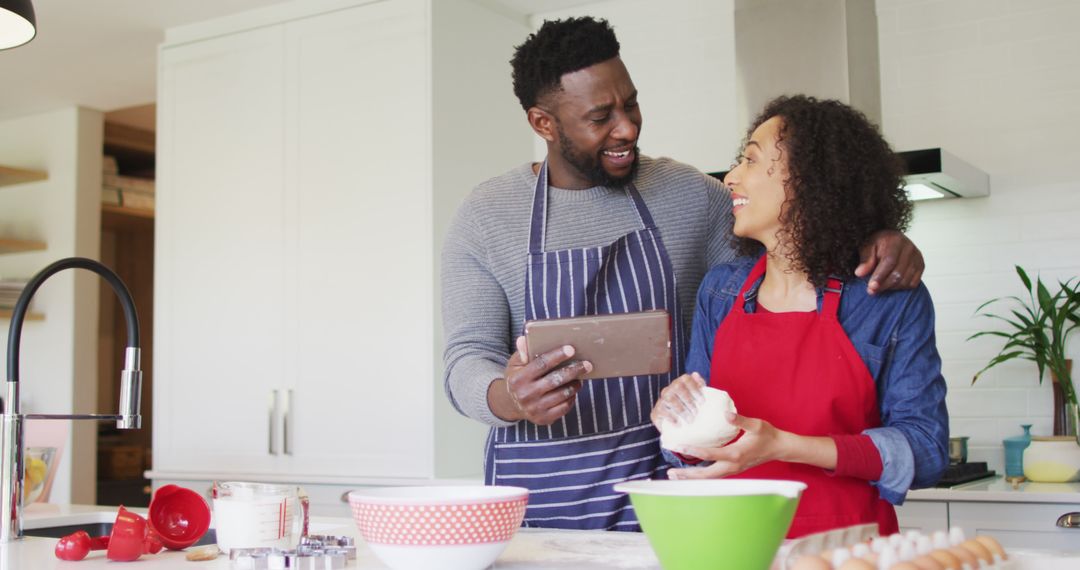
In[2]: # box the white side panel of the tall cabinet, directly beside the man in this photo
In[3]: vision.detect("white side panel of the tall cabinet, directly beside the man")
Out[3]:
[431,0,534,477]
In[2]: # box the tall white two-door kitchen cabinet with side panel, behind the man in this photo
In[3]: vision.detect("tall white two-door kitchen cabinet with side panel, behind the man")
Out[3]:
[151,0,531,486]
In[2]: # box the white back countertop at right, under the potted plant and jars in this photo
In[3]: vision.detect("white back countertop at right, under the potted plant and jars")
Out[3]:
[907,475,1080,503]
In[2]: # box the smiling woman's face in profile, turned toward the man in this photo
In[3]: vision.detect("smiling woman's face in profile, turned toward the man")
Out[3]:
[724,117,787,250]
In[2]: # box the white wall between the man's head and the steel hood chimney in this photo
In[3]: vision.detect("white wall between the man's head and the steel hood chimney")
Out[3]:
[531,0,744,172]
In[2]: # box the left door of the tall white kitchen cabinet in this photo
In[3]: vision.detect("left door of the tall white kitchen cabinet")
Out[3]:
[153,28,286,470]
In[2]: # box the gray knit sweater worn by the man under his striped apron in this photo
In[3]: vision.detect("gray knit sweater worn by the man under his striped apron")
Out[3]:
[442,157,734,426]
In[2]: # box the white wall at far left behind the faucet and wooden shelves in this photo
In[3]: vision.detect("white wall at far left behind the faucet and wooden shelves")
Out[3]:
[0,108,103,503]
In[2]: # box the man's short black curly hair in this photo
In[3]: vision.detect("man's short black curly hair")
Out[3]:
[510,16,619,110]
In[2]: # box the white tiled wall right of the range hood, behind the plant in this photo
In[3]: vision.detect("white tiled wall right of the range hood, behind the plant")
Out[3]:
[877,0,1080,472]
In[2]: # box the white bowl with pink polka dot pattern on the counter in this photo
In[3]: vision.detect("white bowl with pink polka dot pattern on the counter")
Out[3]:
[349,486,529,570]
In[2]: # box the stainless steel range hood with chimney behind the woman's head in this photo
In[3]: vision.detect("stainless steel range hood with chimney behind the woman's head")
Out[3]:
[734,0,990,200]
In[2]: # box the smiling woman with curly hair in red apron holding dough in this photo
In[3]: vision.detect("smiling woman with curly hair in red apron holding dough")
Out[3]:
[651,96,948,538]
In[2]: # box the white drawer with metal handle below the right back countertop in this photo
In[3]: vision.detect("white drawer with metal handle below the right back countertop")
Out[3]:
[949,502,1080,552]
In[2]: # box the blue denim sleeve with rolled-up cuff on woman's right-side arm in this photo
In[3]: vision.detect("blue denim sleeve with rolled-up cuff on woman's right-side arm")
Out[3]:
[864,285,948,504]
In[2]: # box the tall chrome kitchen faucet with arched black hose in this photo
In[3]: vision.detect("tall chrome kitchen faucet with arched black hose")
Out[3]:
[0,257,143,544]
